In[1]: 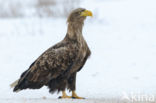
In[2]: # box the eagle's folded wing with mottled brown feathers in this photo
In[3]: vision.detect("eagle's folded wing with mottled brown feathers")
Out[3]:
[14,43,78,91]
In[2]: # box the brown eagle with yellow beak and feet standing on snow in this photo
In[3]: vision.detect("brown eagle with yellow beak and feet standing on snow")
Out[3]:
[12,8,92,99]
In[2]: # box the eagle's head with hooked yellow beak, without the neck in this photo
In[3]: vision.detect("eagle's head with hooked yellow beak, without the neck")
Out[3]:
[67,8,93,23]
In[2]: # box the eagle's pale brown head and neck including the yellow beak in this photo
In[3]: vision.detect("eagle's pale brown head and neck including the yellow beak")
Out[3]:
[67,8,92,39]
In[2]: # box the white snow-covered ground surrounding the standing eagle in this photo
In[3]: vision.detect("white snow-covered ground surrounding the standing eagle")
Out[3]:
[0,0,156,103]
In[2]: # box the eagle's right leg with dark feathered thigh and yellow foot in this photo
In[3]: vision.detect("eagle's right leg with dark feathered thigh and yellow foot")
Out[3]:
[68,73,84,99]
